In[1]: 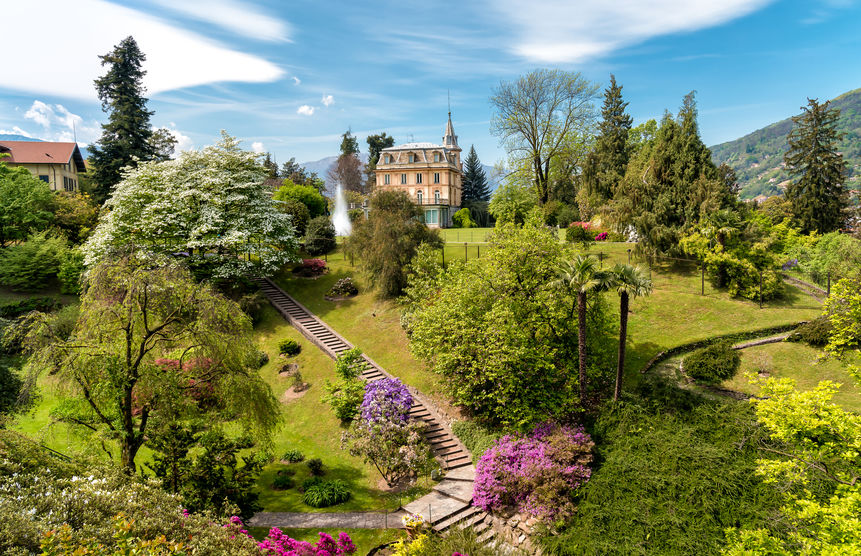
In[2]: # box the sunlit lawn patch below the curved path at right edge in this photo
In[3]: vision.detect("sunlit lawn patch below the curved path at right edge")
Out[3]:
[722,342,861,412]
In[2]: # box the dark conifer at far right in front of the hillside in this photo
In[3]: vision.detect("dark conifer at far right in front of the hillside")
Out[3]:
[783,98,849,233]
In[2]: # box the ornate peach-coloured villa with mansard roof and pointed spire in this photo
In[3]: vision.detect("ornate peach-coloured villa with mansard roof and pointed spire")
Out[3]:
[375,112,463,228]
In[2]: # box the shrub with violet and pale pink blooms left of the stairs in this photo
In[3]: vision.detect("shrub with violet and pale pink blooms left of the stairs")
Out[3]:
[344,378,430,486]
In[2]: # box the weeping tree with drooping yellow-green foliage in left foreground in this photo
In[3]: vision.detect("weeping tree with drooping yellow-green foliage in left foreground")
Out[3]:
[27,252,280,474]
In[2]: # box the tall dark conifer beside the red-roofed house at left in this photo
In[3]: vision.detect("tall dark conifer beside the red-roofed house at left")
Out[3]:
[90,37,173,200]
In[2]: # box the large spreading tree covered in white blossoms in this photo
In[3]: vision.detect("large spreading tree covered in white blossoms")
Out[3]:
[83,131,298,279]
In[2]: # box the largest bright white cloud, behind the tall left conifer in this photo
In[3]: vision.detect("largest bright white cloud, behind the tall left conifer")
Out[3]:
[0,0,284,100]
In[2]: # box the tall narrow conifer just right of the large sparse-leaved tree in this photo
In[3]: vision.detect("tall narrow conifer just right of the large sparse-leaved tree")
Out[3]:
[583,74,633,204]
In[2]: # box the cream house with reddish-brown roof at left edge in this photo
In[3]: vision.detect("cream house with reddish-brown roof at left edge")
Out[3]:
[0,141,87,191]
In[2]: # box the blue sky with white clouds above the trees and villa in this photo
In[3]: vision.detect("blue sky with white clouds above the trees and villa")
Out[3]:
[0,0,861,164]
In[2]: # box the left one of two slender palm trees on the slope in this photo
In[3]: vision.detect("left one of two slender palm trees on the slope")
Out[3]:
[555,255,611,405]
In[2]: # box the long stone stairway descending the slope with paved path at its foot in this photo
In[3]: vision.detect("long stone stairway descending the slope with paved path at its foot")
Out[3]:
[250,278,495,543]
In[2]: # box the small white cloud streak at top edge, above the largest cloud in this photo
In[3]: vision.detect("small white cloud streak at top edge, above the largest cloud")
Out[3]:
[153,0,290,42]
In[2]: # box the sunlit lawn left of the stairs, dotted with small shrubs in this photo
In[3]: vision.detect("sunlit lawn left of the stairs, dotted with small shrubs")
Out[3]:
[255,307,430,512]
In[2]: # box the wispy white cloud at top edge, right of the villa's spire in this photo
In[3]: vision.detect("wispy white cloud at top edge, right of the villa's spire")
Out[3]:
[489,0,772,63]
